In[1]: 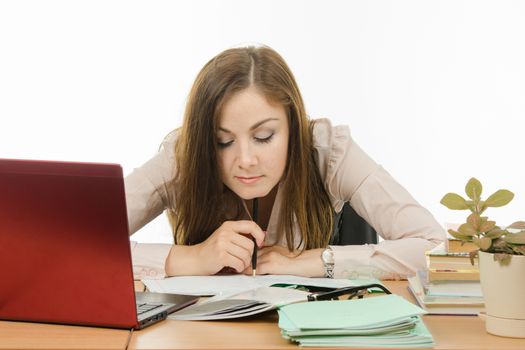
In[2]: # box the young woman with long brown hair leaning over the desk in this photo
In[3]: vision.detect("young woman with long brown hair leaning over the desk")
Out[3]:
[126,47,445,278]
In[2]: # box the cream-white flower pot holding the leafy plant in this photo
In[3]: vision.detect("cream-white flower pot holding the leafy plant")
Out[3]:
[479,252,525,338]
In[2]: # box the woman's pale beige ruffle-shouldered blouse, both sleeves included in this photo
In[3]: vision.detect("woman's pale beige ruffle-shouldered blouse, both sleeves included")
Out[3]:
[125,119,446,279]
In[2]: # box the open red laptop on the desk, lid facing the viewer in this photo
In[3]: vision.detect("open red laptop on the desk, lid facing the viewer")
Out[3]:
[0,159,196,329]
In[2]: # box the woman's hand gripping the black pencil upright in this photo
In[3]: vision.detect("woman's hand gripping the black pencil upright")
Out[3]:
[166,220,265,276]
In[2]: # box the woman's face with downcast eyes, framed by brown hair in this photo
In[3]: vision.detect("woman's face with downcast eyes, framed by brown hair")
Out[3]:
[216,86,289,199]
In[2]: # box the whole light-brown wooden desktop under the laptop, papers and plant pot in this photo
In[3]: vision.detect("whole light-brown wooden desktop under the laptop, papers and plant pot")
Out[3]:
[0,281,525,350]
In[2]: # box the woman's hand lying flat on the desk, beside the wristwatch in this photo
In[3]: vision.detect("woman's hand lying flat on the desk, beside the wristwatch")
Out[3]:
[244,245,324,277]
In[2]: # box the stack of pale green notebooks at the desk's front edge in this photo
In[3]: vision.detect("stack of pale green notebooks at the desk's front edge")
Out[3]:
[279,295,434,348]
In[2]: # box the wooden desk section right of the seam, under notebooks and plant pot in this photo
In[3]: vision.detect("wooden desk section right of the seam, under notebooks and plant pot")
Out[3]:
[129,281,525,350]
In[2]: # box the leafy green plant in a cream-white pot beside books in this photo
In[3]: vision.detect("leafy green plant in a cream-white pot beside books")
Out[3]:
[441,178,525,338]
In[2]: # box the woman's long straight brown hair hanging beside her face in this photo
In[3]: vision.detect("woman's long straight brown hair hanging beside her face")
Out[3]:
[168,46,333,250]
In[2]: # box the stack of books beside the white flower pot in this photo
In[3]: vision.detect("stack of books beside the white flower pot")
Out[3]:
[408,242,484,315]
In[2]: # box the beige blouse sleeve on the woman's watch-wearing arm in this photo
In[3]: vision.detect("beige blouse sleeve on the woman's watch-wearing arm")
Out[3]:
[314,120,446,279]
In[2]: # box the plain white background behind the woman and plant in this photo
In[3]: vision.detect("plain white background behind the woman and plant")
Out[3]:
[0,0,525,242]
